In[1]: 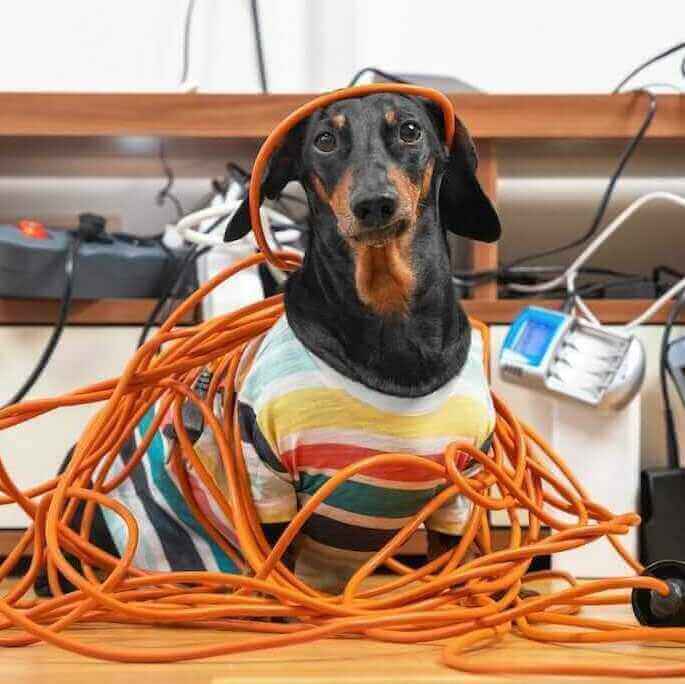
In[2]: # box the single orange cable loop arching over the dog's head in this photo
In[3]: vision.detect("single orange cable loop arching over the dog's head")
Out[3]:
[249,83,456,270]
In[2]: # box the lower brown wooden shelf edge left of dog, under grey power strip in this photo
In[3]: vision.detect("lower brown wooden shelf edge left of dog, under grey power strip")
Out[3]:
[0,299,193,325]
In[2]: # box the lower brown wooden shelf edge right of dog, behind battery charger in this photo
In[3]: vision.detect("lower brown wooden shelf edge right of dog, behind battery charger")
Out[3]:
[462,299,685,325]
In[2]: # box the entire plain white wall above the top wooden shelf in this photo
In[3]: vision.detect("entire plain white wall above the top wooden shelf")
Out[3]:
[0,0,685,93]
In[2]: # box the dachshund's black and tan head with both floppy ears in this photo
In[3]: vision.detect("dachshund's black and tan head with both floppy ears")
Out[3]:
[226,93,500,315]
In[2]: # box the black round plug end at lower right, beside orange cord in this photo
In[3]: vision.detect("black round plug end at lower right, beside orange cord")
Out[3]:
[632,560,685,627]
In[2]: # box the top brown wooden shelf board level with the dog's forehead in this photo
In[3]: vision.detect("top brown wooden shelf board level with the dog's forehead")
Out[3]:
[0,93,685,140]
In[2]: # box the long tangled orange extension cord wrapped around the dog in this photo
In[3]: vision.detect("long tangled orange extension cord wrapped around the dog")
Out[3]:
[0,84,685,677]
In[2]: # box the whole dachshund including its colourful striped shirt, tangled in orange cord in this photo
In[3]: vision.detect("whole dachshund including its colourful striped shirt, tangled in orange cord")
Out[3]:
[37,93,501,592]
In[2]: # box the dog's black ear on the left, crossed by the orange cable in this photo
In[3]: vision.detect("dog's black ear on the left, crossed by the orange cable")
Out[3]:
[224,122,304,242]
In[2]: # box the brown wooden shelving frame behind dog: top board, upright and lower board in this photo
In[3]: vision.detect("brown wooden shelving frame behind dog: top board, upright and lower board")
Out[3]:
[0,93,685,325]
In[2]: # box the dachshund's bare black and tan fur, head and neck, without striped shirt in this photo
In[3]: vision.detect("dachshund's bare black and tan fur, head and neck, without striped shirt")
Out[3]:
[226,94,500,568]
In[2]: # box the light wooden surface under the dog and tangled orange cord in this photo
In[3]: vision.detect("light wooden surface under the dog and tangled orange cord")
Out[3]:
[0,576,685,684]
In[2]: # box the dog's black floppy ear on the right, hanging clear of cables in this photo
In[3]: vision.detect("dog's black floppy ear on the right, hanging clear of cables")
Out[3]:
[423,100,502,242]
